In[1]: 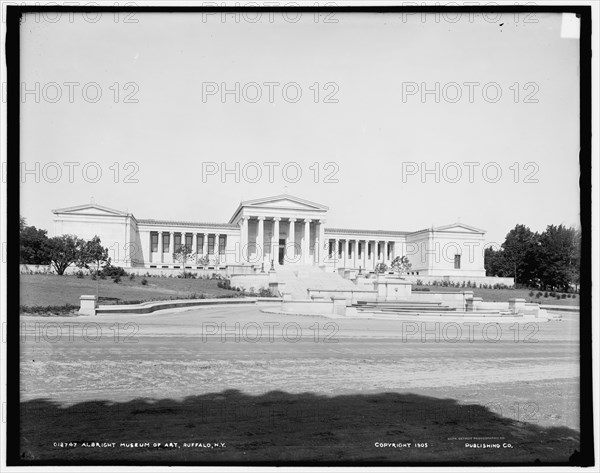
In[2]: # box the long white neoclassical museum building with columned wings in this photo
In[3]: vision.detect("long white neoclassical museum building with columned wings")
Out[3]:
[52,195,485,278]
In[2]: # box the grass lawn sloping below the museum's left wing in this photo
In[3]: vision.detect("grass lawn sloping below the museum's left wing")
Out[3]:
[20,274,241,306]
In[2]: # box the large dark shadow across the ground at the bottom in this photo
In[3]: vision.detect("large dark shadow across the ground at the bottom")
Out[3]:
[20,390,579,465]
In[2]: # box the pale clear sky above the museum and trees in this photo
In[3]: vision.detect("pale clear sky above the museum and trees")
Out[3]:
[21,12,579,243]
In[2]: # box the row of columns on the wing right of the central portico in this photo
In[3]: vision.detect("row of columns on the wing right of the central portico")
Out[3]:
[328,238,395,269]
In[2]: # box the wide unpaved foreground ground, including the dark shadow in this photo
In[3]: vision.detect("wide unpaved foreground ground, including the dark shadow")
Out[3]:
[21,306,579,464]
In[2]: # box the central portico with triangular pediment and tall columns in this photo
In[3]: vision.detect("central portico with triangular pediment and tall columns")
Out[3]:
[229,195,329,265]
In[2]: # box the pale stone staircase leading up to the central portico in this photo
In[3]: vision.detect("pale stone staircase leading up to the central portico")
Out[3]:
[275,265,357,299]
